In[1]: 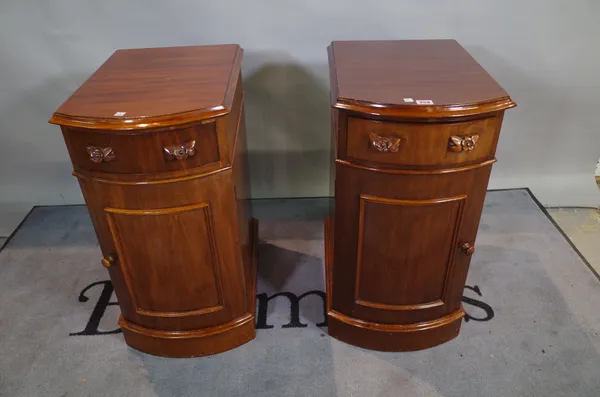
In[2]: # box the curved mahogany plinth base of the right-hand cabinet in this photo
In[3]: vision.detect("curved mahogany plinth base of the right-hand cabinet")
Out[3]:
[327,309,464,352]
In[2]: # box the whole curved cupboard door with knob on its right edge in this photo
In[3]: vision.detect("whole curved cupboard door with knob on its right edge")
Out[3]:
[330,164,490,324]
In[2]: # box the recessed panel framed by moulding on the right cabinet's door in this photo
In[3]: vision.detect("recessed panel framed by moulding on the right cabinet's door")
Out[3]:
[355,195,466,311]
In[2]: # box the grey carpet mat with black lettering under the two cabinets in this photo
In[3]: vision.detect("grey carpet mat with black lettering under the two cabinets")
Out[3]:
[0,190,600,397]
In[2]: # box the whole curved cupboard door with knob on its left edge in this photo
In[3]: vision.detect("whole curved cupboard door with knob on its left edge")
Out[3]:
[80,172,249,331]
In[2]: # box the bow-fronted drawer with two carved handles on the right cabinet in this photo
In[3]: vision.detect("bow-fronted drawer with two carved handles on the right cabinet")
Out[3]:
[346,117,501,167]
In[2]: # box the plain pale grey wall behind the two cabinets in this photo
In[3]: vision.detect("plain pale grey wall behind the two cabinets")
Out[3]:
[0,0,600,234]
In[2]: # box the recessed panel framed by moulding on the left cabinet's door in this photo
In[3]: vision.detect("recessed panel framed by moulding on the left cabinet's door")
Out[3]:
[105,202,225,317]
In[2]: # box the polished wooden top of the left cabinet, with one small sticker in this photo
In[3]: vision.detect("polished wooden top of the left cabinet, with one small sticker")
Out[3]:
[50,44,243,130]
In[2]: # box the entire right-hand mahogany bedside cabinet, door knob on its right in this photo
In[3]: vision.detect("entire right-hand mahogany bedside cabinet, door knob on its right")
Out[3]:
[325,40,516,351]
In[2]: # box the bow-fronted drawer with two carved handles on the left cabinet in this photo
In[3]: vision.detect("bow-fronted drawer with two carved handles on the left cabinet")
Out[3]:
[63,123,219,174]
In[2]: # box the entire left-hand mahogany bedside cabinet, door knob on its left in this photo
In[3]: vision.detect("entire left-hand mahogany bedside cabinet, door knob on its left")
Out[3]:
[50,45,256,357]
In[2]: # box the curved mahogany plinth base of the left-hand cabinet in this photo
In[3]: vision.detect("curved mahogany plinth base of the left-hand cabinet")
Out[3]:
[119,315,256,358]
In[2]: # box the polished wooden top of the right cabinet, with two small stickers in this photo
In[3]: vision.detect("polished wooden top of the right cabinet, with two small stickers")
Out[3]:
[328,40,516,117]
